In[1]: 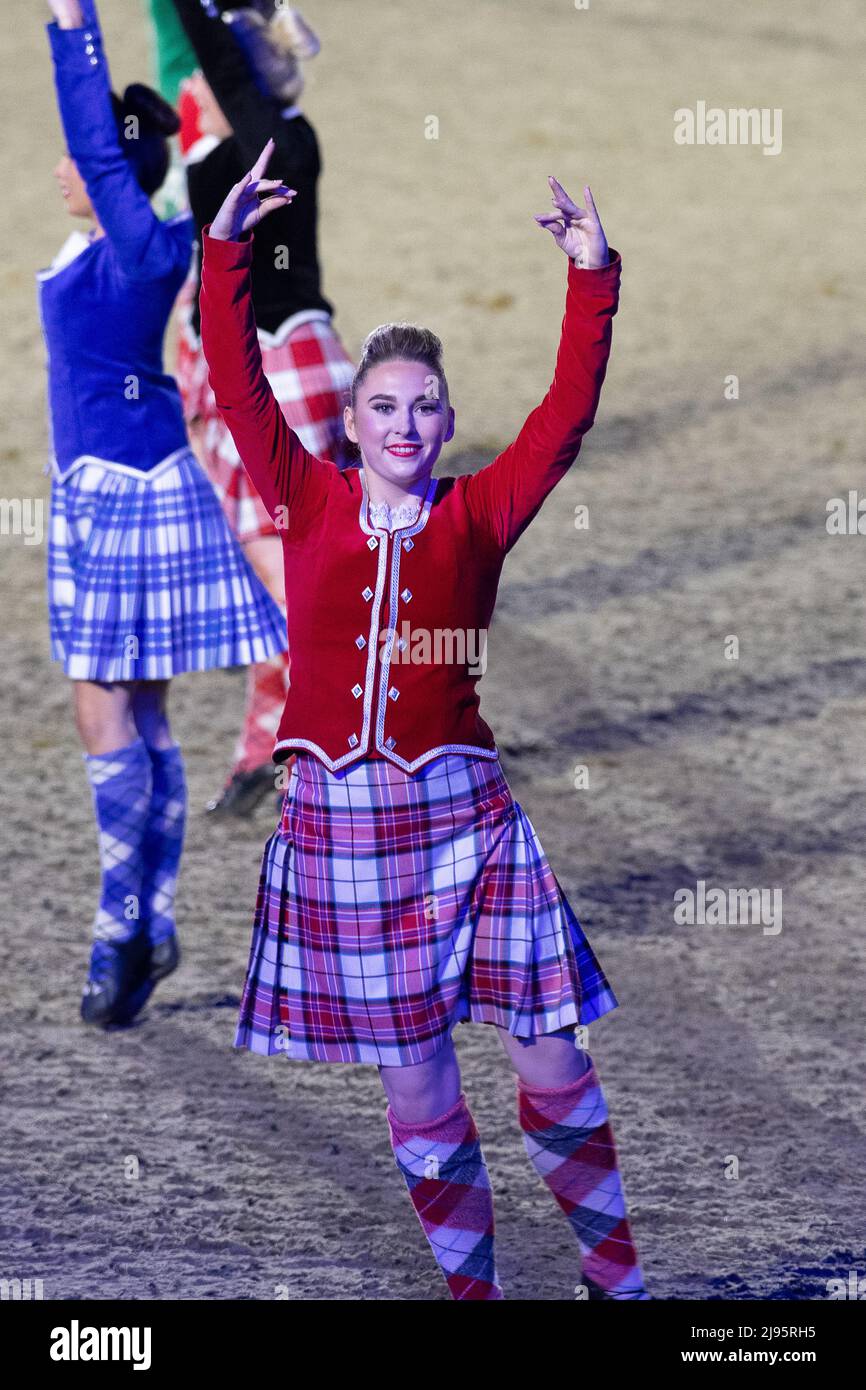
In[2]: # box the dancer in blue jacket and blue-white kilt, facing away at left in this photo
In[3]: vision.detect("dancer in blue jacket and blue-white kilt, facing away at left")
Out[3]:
[38,0,285,1026]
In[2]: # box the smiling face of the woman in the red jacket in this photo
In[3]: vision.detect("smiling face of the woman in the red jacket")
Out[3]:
[343,360,455,488]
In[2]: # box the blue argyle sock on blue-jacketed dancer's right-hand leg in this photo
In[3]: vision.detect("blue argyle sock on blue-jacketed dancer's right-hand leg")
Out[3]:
[142,744,186,947]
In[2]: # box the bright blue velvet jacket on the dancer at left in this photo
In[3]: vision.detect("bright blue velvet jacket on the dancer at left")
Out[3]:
[36,0,193,477]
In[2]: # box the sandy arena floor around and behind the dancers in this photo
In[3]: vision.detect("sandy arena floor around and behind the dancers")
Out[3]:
[0,0,866,1300]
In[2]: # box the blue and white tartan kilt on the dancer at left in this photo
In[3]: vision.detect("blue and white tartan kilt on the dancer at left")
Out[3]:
[47,449,286,681]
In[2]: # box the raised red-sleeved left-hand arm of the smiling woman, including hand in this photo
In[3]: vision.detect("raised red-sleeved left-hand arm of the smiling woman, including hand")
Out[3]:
[199,143,335,531]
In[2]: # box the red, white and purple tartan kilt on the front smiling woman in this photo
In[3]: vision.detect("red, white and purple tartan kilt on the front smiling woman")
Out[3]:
[235,751,617,1066]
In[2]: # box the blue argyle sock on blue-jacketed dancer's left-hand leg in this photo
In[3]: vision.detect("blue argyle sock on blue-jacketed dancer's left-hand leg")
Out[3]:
[83,738,153,941]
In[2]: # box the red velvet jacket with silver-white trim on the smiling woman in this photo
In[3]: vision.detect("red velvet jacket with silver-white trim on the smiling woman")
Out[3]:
[200,227,621,773]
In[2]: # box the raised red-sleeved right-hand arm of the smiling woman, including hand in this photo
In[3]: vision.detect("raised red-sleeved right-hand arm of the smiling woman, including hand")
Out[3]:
[466,179,621,550]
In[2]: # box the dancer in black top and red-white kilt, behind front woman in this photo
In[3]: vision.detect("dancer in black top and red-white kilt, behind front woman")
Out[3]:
[166,0,354,815]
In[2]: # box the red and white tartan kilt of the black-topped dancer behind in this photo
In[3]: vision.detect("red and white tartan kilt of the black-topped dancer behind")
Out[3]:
[175,286,354,541]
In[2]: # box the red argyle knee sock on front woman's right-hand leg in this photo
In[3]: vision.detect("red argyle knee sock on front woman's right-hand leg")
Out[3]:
[517,1054,649,1300]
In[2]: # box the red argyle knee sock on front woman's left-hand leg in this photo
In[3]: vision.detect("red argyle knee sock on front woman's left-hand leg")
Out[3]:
[386,1093,503,1300]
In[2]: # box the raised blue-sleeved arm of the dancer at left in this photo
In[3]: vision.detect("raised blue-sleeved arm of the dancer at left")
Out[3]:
[46,0,183,279]
